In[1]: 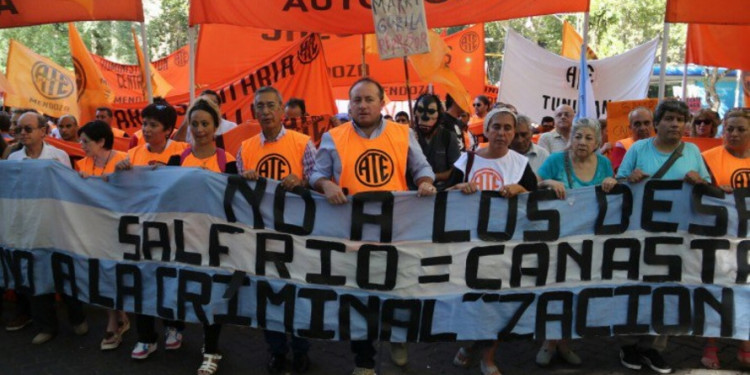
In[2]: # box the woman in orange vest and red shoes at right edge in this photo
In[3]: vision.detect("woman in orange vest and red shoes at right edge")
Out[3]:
[701,109,750,369]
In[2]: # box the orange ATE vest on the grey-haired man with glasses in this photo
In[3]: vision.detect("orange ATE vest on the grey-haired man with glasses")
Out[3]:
[240,129,310,180]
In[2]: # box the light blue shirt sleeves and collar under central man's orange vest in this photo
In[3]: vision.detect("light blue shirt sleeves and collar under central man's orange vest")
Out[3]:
[310,118,435,186]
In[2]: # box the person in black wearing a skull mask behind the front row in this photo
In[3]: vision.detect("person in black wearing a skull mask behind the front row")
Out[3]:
[407,94,461,190]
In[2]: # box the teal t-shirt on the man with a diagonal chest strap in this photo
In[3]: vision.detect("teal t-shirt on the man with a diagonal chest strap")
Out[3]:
[617,137,711,182]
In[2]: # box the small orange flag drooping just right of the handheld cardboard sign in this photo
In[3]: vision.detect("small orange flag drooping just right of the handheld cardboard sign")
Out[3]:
[409,30,471,112]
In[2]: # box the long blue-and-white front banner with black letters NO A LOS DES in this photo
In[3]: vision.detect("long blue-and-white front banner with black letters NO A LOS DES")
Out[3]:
[0,161,750,342]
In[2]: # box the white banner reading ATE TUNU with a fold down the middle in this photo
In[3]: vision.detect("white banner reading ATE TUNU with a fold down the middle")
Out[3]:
[498,30,658,121]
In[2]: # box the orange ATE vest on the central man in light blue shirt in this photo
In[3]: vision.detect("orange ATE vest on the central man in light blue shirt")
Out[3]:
[328,121,409,195]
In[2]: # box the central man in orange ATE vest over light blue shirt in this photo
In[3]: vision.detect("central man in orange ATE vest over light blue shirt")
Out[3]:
[310,78,437,375]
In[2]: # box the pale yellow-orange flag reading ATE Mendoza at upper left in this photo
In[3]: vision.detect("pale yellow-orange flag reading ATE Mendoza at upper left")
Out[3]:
[5,39,78,118]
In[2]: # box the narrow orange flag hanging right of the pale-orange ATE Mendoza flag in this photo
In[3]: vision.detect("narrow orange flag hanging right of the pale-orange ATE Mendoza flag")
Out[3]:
[68,22,115,124]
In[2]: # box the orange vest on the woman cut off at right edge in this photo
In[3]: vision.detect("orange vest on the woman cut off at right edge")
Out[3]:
[702,146,750,189]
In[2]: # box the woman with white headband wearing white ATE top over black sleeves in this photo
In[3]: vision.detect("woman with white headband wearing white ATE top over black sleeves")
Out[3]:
[451,108,537,375]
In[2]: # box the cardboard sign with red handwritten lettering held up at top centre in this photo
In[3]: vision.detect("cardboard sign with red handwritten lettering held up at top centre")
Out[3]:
[372,0,430,60]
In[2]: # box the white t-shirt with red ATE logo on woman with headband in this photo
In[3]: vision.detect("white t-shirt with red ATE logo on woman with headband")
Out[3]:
[453,150,529,190]
